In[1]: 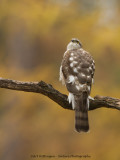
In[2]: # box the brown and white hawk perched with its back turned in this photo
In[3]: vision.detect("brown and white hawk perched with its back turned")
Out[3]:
[60,38,95,132]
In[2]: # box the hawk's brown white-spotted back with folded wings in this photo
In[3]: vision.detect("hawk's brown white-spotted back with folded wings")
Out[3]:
[61,49,95,94]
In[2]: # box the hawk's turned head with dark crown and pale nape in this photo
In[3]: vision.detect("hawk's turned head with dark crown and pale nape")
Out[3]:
[67,38,82,50]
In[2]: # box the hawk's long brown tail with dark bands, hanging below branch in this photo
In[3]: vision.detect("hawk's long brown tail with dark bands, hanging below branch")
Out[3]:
[74,92,89,132]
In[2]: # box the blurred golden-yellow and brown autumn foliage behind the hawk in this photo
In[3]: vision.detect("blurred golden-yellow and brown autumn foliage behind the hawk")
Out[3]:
[0,0,120,160]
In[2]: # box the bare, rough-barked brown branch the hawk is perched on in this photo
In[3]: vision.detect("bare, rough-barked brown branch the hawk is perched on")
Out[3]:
[0,78,120,110]
